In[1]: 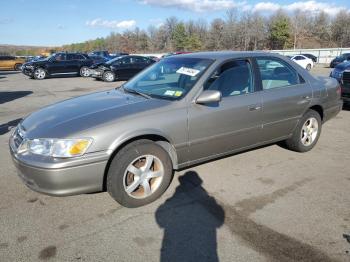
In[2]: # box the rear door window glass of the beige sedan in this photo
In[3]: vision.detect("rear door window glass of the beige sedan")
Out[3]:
[256,58,301,90]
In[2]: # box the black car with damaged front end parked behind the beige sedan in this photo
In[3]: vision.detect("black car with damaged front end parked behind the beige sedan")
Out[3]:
[90,55,155,82]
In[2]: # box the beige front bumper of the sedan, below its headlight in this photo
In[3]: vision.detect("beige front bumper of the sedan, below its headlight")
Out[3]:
[10,148,108,196]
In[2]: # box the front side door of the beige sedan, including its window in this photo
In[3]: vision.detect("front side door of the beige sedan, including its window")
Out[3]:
[189,59,262,161]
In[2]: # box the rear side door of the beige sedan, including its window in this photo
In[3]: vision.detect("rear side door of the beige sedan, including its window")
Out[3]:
[256,57,312,142]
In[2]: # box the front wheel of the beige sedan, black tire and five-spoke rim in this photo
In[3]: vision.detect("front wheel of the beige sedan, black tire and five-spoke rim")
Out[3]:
[107,140,173,208]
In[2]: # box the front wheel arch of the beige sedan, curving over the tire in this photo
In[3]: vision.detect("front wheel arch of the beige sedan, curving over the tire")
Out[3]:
[103,132,178,191]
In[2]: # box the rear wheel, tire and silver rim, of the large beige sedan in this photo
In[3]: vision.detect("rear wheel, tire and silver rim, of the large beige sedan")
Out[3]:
[285,109,322,153]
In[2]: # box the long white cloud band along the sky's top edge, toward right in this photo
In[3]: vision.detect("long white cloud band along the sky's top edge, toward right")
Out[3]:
[141,0,347,16]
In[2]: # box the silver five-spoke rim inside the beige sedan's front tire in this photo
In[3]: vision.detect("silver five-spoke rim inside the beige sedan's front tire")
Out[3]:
[123,155,164,199]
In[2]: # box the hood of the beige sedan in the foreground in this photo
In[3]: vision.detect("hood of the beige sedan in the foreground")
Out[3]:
[21,89,169,139]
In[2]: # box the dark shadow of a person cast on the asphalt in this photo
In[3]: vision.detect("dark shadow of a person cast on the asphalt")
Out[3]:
[155,171,225,262]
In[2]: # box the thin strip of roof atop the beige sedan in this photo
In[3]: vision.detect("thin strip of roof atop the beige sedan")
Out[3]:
[171,51,282,60]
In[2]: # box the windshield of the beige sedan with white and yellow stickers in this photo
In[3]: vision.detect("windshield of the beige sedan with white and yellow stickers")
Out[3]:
[124,57,213,100]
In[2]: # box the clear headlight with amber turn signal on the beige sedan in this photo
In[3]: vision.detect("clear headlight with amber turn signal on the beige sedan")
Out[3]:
[17,138,92,158]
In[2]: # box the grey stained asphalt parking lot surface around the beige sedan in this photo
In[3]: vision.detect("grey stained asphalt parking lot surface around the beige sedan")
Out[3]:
[0,68,350,262]
